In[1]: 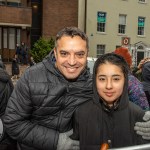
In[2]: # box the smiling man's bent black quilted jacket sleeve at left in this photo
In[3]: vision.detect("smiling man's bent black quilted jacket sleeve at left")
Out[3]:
[4,71,59,150]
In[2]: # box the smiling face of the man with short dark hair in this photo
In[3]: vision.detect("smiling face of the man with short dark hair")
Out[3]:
[54,36,88,80]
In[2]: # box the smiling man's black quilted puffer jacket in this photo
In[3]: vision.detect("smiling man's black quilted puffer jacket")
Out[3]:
[4,51,92,150]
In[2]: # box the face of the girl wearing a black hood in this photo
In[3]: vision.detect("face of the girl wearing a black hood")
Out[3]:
[96,62,125,106]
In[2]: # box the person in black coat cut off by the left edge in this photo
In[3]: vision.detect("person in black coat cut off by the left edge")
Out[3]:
[0,60,17,150]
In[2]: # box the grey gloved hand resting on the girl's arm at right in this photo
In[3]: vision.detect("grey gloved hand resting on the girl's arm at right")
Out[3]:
[134,111,150,140]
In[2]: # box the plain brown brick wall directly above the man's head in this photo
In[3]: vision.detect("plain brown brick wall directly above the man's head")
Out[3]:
[42,0,78,37]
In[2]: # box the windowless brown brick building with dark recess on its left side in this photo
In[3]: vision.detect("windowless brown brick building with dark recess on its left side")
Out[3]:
[31,0,78,47]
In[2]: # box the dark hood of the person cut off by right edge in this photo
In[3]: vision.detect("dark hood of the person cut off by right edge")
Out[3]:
[142,62,150,91]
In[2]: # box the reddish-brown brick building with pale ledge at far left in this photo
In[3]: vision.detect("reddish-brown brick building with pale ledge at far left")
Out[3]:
[0,0,32,61]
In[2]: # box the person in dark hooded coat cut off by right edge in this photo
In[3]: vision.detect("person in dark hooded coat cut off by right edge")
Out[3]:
[141,59,150,106]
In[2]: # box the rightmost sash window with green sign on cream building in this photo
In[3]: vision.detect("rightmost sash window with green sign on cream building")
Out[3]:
[138,17,145,35]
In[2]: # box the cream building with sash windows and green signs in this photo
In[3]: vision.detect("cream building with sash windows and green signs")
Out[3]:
[84,0,150,65]
